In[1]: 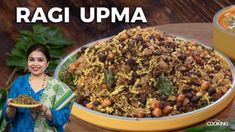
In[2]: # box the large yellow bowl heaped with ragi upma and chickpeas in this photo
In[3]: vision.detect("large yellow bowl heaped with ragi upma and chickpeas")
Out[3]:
[55,27,235,131]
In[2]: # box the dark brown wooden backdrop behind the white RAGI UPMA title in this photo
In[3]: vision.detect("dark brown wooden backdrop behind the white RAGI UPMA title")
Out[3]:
[0,0,235,88]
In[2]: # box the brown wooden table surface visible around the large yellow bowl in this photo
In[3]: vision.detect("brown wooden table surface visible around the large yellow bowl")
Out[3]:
[65,23,235,132]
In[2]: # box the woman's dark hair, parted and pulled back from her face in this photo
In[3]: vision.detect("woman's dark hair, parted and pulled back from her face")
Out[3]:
[27,44,51,61]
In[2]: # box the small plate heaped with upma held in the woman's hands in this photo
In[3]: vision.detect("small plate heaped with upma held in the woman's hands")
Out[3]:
[10,94,39,107]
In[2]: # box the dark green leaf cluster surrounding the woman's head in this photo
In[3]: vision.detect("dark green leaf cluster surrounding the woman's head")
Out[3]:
[7,25,74,73]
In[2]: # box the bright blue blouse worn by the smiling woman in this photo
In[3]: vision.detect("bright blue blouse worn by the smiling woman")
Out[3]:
[2,74,70,132]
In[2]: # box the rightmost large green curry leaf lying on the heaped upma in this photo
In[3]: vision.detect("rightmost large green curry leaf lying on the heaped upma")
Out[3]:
[158,75,174,96]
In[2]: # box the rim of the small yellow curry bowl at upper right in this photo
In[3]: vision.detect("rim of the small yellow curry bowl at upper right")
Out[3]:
[213,5,235,36]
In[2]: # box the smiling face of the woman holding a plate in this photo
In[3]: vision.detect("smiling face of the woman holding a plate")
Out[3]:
[28,51,49,76]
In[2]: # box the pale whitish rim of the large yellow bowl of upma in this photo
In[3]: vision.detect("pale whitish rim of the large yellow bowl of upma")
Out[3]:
[54,36,235,121]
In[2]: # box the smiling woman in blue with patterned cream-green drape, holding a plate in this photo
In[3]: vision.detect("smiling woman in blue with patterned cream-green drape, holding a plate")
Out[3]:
[2,44,74,132]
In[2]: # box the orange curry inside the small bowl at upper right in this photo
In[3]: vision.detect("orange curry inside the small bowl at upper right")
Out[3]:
[218,10,235,32]
